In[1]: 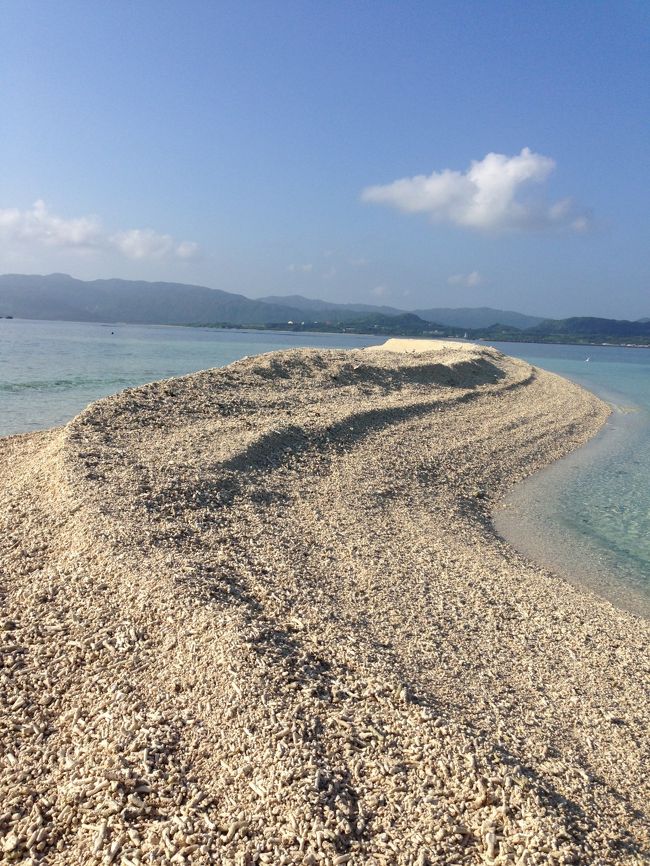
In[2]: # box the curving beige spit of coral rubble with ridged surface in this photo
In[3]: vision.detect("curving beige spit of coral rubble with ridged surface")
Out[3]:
[0,346,650,866]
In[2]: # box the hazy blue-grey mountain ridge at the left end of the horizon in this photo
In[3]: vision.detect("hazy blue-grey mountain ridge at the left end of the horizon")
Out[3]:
[0,274,303,325]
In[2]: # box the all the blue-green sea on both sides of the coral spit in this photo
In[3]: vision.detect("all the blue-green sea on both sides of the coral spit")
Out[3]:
[0,319,650,616]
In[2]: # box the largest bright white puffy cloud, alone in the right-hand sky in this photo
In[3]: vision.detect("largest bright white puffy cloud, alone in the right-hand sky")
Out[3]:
[361,147,588,231]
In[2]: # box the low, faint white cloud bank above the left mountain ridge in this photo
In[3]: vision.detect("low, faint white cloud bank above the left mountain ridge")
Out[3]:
[0,199,198,259]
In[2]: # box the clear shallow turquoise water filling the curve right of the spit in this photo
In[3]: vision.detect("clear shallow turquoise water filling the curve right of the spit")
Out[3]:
[495,343,650,616]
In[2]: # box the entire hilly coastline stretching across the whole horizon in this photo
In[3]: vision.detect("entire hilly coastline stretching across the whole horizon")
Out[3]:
[0,274,650,347]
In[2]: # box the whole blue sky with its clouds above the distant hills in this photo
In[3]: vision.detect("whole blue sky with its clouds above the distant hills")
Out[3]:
[0,0,650,318]
